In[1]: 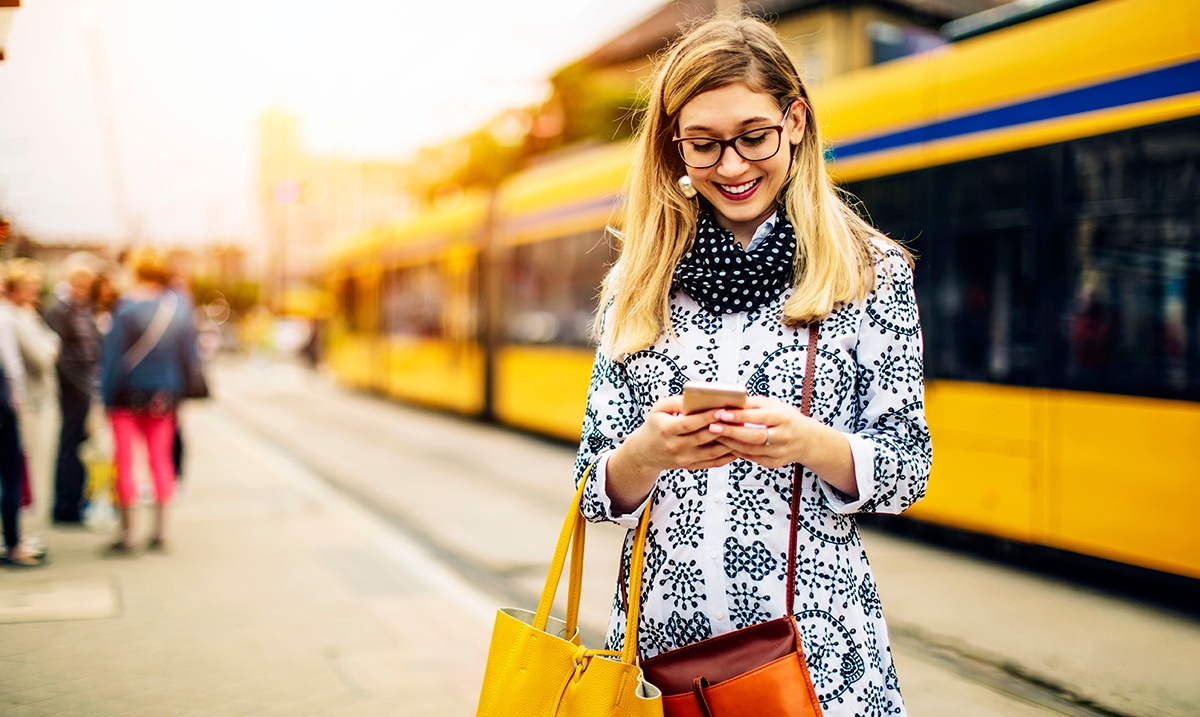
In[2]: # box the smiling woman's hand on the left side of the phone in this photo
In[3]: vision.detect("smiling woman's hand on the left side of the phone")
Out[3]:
[606,396,737,514]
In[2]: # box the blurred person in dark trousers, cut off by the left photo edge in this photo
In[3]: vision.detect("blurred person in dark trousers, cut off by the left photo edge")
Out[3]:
[0,262,46,567]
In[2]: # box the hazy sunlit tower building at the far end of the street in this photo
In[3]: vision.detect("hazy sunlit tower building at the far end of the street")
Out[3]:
[258,112,413,302]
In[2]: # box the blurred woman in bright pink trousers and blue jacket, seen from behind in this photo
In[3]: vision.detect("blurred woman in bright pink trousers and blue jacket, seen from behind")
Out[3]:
[101,248,198,553]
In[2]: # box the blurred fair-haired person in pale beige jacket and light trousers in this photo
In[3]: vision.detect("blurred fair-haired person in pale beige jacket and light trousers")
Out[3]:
[5,259,61,523]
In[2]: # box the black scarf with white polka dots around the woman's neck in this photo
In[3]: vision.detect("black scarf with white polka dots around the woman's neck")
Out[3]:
[674,210,796,314]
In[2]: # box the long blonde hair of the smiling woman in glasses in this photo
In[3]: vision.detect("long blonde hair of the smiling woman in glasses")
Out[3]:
[596,11,912,360]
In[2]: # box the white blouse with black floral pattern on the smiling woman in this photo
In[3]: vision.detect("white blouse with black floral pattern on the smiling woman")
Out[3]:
[576,242,932,717]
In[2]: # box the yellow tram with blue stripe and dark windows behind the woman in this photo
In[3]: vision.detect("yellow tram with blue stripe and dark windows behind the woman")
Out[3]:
[329,0,1200,578]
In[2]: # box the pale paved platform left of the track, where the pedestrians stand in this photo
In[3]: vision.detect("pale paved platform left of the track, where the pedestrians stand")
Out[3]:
[0,393,494,717]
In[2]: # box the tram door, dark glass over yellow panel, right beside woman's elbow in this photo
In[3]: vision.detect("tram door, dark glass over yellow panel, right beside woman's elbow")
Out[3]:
[913,155,1046,541]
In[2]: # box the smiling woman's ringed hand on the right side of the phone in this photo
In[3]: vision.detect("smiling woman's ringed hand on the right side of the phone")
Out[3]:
[708,396,858,498]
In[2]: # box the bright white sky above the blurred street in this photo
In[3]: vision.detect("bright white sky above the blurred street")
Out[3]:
[0,0,662,242]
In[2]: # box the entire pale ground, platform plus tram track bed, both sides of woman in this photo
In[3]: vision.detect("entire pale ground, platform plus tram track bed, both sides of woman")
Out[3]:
[0,362,1200,717]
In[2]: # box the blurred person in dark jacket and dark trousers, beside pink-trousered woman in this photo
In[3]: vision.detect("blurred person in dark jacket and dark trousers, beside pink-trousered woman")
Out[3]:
[46,252,100,524]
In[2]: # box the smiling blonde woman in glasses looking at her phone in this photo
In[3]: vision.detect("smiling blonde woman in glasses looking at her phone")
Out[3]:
[576,16,931,716]
